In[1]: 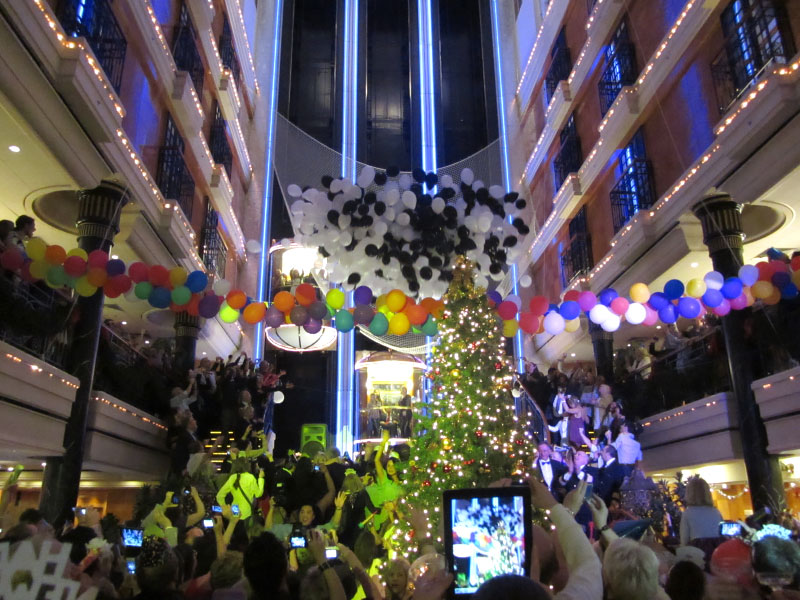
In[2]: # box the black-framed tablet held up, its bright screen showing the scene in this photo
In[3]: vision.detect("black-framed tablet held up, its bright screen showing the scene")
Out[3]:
[443,486,533,598]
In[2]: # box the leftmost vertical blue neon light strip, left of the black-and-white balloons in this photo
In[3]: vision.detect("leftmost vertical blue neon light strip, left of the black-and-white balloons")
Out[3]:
[253,0,283,359]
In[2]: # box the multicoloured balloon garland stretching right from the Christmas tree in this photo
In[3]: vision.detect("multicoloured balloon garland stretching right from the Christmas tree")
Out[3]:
[487,257,800,337]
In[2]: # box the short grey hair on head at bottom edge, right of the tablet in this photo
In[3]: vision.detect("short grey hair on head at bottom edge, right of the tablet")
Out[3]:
[603,538,658,600]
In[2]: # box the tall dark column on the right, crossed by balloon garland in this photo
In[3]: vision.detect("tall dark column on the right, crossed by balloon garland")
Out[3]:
[692,192,784,510]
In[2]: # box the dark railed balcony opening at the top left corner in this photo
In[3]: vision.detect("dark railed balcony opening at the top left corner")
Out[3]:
[56,0,128,93]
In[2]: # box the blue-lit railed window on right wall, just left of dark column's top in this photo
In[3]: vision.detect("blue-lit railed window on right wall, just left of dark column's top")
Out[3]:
[611,129,655,233]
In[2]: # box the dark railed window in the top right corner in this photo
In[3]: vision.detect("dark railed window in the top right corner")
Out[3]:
[711,0,795,113]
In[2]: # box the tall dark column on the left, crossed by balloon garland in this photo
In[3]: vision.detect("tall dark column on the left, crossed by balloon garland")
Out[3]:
[40,181,128,530]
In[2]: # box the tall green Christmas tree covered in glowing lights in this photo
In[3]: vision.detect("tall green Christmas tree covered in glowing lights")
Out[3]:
[393,257,533,559]
